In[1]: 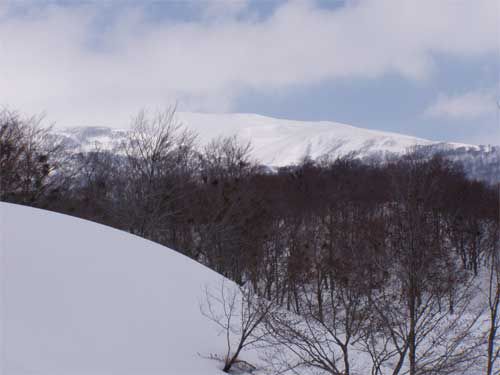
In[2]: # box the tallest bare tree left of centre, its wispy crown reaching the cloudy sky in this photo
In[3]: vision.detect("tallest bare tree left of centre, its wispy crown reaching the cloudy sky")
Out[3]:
[118,107,195,245]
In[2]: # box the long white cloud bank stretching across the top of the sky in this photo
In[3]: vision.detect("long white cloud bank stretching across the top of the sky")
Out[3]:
[0,0,498,126]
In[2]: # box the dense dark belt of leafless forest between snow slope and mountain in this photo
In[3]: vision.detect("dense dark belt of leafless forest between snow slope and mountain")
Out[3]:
[0,110,500,375]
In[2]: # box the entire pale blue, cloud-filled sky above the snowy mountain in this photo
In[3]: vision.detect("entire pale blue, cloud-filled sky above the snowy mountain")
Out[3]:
[0,0,500,144]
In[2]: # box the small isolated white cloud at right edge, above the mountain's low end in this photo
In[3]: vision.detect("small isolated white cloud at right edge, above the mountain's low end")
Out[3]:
[425,90,496,119]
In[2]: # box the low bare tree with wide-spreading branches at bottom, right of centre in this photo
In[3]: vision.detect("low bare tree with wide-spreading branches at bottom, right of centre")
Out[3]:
[266,268,369,375]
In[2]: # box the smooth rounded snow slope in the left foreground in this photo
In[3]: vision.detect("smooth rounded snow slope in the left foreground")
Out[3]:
[0,203,248,375]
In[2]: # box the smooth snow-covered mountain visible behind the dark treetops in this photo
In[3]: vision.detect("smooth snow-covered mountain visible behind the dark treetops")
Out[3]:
[52,112,477,166]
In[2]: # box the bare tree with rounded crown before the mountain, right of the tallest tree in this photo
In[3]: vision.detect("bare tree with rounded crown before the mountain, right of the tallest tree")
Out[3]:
[193,137,259,284]
